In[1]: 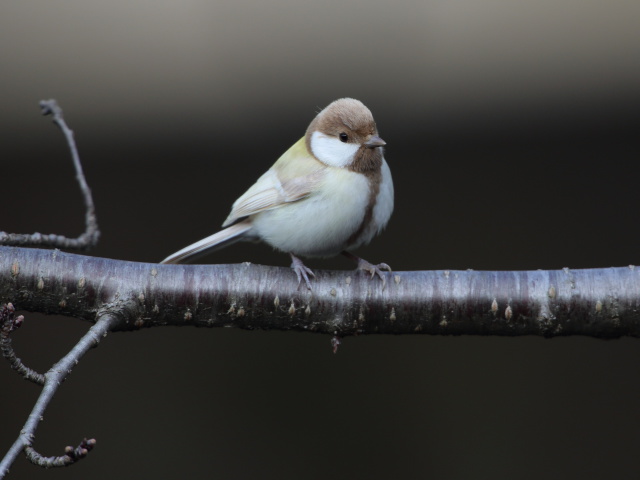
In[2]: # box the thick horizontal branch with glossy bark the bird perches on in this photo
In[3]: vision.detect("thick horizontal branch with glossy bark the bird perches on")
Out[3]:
[0,247,640,338]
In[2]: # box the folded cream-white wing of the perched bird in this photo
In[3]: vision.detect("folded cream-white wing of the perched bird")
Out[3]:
[222,137,326,227]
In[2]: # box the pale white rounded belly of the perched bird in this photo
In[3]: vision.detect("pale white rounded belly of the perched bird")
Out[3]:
[252,170,370,257]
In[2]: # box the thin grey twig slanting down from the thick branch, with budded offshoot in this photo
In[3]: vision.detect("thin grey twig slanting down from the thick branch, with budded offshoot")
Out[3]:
[0,314,117,479]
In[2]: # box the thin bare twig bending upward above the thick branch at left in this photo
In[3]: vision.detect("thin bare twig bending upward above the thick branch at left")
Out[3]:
[0,99,100,250]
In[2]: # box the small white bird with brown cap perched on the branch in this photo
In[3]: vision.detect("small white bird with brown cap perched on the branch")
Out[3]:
[161,98,393,289]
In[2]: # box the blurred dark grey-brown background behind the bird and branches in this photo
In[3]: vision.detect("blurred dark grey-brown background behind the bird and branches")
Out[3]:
[0,0,640,479]
